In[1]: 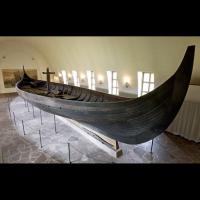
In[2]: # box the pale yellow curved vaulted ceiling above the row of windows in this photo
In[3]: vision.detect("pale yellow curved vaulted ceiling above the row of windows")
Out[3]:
[0,36,200,83]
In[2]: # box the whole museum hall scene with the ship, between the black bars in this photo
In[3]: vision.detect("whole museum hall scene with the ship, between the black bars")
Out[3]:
[0,36,200,164]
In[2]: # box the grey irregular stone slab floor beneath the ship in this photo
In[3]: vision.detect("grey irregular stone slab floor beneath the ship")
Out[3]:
[0,95,200,163]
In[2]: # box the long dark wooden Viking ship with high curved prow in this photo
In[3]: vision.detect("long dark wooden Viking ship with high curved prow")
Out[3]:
[16,45,195,144]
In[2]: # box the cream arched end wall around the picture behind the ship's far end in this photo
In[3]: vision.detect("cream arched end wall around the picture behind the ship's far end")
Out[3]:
[0,40,48,93]
